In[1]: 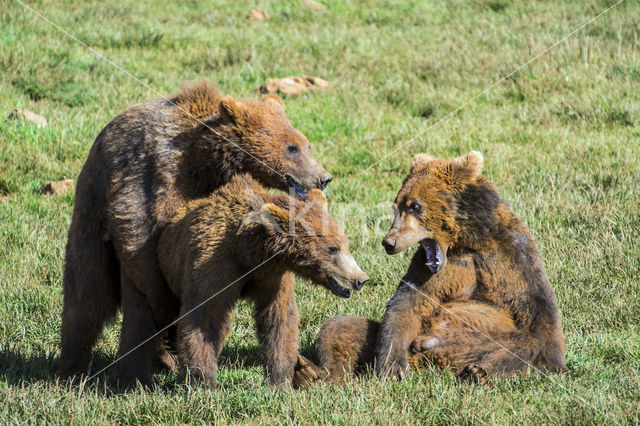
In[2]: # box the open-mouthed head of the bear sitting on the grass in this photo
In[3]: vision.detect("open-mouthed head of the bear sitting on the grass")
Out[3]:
[382,151,485,274]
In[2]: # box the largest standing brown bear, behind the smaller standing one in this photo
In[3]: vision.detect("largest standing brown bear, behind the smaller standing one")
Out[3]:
[58,82,331,383]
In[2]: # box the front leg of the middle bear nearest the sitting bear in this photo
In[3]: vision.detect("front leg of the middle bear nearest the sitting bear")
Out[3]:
[252,272,300,386]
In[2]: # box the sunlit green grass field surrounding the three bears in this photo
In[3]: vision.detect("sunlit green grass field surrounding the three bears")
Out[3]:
[0,0,640,424]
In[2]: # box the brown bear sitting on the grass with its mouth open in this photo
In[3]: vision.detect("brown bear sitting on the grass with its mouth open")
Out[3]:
[295,151,568,386]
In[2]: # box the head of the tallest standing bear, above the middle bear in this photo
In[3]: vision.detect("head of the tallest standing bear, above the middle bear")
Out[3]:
[219,94,333,198]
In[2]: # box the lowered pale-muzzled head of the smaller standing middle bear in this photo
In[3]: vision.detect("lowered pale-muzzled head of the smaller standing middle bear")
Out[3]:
[241,189,369,298]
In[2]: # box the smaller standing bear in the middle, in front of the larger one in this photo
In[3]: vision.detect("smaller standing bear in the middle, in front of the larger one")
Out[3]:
[158,175,369,386]
